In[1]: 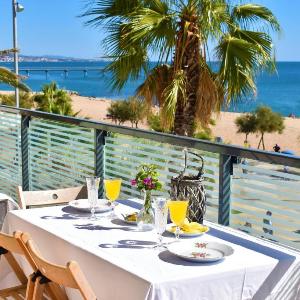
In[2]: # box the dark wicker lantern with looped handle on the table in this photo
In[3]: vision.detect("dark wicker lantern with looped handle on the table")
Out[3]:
[170,150,206,224]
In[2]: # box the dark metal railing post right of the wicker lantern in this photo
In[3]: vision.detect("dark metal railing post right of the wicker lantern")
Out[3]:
[218,154,233,226]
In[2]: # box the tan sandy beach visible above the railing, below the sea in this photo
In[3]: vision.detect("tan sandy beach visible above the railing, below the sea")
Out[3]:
[0,92,300,155]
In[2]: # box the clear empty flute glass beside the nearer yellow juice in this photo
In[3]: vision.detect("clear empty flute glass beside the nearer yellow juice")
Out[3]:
[154,197,168,247]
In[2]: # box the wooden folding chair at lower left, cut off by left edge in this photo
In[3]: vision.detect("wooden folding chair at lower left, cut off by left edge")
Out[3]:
[0,233,36,300]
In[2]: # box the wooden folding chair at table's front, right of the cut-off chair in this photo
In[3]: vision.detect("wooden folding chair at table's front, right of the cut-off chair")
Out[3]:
[22,234,96,300]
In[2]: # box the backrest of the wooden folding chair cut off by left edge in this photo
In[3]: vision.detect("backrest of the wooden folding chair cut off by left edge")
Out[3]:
[0,232,36,284]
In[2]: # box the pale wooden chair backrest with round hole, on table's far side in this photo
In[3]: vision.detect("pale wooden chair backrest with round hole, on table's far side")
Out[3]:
[18,185,87,209]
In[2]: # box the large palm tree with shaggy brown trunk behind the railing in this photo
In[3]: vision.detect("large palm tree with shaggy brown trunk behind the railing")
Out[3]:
[82,0,280,135]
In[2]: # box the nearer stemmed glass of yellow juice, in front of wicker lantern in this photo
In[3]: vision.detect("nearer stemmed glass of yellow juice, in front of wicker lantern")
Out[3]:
[168,199,189,241]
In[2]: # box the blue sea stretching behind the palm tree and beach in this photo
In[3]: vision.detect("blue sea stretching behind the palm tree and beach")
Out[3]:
[0,61,300,117]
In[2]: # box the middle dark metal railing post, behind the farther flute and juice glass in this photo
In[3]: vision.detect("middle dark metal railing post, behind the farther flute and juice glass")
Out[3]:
[95,129,107,198]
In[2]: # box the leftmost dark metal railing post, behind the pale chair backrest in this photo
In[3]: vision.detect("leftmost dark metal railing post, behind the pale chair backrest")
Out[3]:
[21,115,30,191]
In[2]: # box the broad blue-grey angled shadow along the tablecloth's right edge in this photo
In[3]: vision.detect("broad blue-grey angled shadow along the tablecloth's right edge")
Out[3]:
[208,228,300,300]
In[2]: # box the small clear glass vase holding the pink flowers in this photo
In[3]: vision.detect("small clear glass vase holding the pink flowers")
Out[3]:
[137,191,154,231]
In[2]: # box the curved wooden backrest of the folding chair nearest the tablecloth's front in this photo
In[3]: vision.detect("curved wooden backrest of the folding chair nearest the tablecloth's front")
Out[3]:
[22,234,96,300]
